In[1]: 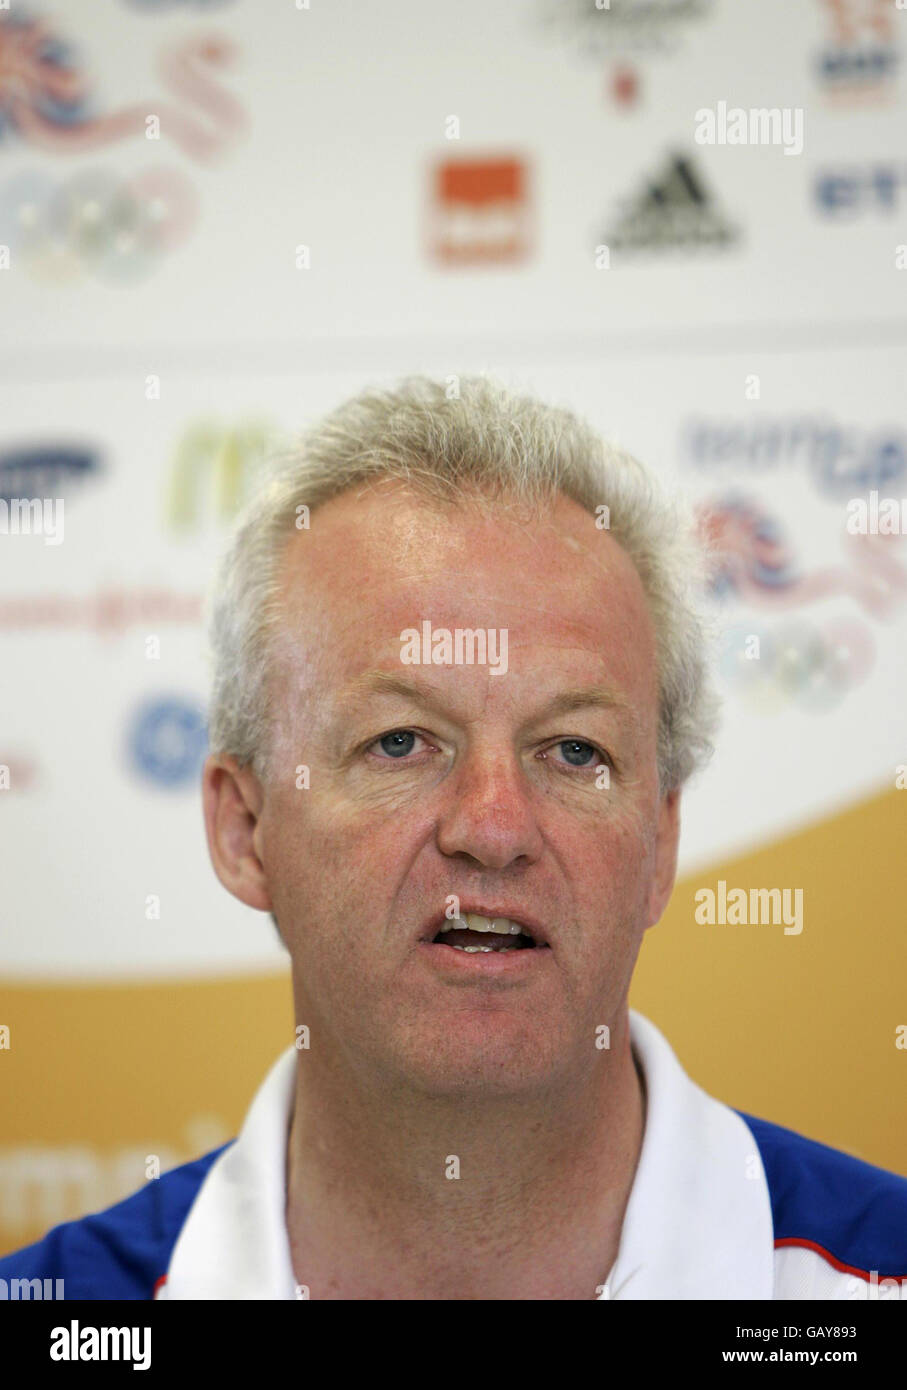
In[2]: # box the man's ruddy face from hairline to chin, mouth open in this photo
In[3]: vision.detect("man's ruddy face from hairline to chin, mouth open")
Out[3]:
[244,482,676,1095]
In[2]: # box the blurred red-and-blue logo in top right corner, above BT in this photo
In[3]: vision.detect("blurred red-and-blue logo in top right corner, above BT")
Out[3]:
[815,0,900,103]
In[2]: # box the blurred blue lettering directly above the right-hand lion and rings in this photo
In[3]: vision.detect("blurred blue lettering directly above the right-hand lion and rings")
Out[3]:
[679,416,907,502]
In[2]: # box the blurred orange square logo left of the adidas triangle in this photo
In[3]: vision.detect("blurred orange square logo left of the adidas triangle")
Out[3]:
[428,157,531,265]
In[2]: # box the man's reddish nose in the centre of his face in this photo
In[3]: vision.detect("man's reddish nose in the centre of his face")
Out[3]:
[438,748,542,869]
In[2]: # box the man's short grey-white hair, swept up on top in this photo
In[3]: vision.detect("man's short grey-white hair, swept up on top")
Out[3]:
[202,377,717,794]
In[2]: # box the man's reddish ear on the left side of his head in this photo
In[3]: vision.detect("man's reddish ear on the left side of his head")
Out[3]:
[201,755,272,912]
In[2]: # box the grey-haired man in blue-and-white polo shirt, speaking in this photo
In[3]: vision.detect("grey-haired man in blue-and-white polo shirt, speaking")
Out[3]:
[0,378,907,1301]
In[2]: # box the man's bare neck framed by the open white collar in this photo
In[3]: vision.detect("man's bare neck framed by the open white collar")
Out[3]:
[286,1016,644,1300]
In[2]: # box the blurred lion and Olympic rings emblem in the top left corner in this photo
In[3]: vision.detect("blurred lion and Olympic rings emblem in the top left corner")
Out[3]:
[0,6,241,284]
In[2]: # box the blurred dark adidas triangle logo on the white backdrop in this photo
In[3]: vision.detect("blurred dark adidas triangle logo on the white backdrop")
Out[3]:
[601,154,739,252]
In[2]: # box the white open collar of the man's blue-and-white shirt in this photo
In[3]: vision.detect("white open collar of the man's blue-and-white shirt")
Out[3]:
[160,1011,774,1300]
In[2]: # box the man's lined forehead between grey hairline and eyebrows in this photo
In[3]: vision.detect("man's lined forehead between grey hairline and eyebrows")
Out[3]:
[272,488,654,717]
